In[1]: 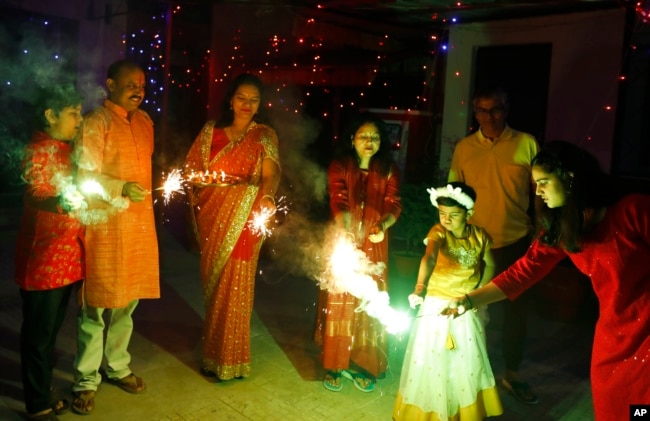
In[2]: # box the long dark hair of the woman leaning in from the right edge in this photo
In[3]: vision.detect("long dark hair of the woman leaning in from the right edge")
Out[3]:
[532,140,619,253]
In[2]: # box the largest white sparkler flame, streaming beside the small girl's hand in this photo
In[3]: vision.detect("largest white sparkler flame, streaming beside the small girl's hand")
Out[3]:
[324,235,411,334]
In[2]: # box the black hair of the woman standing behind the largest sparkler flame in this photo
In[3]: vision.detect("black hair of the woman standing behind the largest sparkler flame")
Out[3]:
[335,113,393,175]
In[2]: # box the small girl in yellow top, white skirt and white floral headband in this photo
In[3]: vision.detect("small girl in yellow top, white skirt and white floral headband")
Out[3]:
[393,182,503,421]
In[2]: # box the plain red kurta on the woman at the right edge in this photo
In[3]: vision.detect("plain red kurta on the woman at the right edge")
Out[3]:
[492,195,650,421]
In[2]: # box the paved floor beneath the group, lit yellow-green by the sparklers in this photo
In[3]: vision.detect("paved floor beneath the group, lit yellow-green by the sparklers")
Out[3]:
[0,215,593,421]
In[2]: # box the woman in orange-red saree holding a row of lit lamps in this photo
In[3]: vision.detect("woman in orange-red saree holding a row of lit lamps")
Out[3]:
[185,74,280,380]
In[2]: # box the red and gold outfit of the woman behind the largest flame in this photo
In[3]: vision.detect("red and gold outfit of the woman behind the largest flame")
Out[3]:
[314,160,402,378]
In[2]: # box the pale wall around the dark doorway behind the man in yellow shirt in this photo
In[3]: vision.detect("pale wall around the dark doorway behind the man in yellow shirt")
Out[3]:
[440,8,625,170]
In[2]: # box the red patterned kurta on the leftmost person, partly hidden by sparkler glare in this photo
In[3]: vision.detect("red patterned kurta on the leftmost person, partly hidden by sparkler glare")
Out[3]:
[14,132,84,290]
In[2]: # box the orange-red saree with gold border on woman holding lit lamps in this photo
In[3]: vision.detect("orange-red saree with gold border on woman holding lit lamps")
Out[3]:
[185,121,279,380]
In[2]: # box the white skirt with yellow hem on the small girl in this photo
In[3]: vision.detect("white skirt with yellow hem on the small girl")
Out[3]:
[393,296,503,421]
